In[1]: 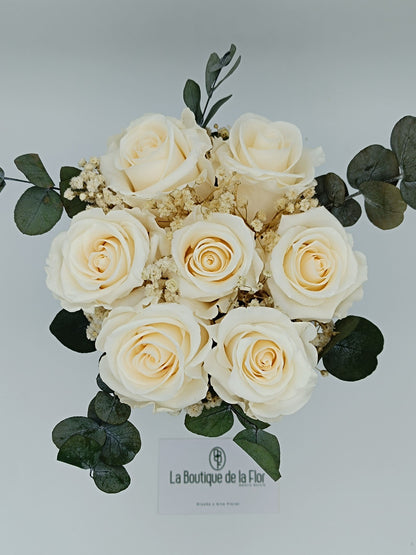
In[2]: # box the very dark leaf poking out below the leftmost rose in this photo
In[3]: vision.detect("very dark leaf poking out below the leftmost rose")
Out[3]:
[49,310,96,353]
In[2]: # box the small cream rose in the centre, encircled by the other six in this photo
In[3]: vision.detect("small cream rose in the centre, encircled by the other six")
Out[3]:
[171,211,263,302]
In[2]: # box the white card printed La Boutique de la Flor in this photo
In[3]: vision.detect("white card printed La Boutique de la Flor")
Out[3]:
[159,438,279,514]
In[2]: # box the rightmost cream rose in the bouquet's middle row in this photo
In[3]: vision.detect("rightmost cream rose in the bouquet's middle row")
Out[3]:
[268,206,367,322]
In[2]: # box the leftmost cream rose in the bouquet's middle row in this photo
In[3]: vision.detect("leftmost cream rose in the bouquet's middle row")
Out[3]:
[46,208,164,312]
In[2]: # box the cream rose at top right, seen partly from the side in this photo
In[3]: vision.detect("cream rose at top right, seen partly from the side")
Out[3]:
[214,114,324,217]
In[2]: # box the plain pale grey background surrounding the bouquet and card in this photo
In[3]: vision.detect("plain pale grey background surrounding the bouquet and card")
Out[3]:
[0,0,416,555]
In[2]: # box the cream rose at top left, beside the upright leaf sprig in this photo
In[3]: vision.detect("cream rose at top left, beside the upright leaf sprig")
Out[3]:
[100,108,211,205]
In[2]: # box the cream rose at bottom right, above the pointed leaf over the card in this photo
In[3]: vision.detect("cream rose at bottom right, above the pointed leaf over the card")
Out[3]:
[205,307,317,422]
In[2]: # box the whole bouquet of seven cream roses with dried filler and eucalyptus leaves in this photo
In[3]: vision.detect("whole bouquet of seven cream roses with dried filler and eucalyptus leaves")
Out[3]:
[0,45,416,493]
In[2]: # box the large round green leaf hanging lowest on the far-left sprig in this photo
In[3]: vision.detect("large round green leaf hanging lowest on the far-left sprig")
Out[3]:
[14,187,63,235]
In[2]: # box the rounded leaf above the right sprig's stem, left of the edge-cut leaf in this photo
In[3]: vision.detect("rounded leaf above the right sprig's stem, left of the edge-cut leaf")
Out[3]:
[347,145,400,189]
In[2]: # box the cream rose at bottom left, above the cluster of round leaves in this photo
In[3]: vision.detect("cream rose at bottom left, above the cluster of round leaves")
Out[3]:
[96,303,211,411]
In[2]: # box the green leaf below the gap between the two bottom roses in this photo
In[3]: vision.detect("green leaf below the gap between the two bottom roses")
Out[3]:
[185,403,234,437]
